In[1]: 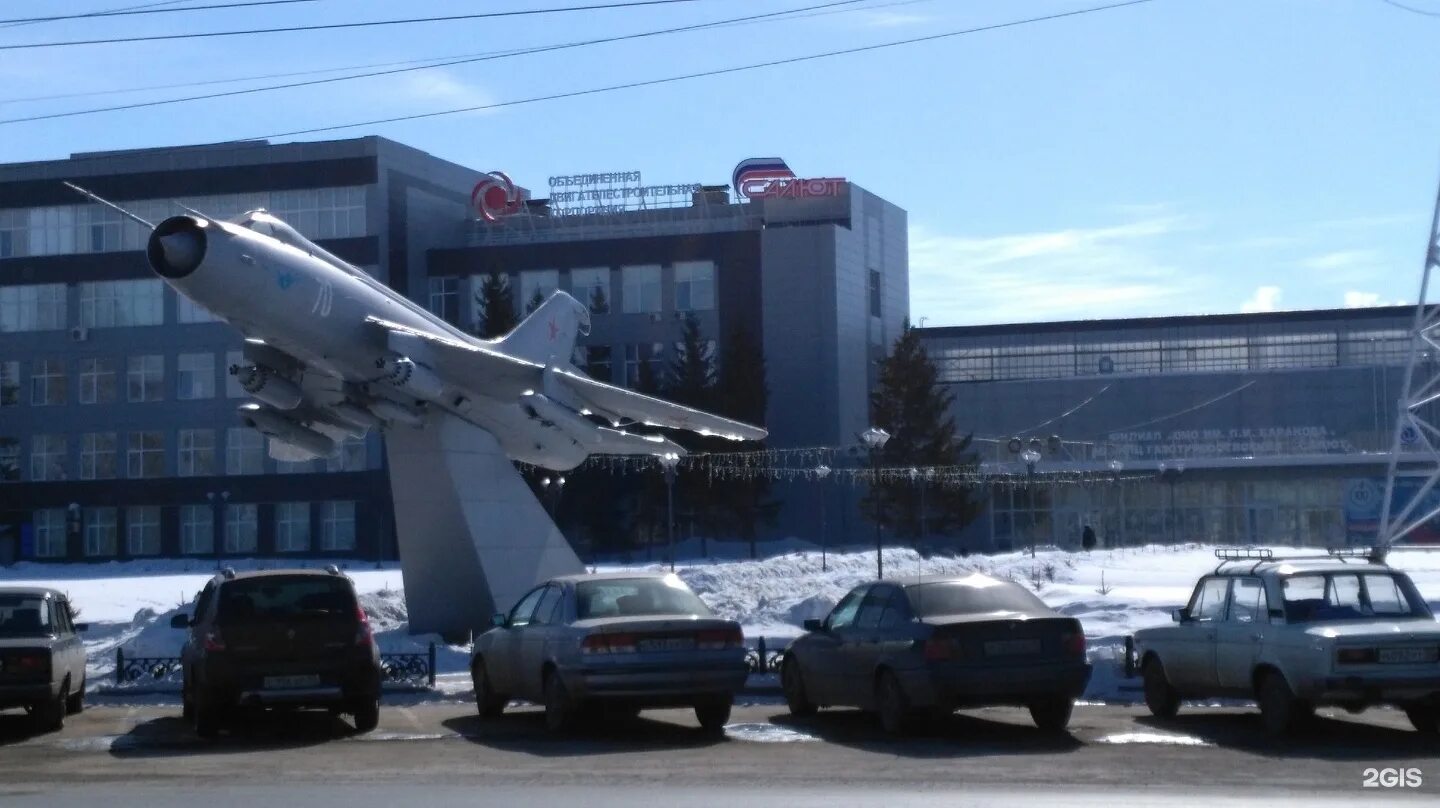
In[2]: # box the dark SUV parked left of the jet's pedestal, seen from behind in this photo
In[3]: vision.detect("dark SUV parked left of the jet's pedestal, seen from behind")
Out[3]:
[170,566,380,737]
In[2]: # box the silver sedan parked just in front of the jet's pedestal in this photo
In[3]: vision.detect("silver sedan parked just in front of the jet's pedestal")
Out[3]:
[469,572,747,732]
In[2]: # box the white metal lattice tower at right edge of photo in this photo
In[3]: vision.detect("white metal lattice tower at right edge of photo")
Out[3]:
[1375,175,1440,557]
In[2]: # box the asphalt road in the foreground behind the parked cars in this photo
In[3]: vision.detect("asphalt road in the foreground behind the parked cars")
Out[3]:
[0,704,1440,808]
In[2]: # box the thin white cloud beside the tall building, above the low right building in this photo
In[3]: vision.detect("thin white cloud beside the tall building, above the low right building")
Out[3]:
[910,216,1194,324]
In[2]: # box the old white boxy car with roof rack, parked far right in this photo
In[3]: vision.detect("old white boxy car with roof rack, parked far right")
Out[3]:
[1133,550,1440,735]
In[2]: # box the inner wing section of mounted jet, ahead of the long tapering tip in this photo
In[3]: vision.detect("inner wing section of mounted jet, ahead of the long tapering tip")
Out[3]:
[366,317,544,396]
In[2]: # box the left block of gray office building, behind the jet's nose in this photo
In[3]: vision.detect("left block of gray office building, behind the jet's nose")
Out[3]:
[0,138,478,563]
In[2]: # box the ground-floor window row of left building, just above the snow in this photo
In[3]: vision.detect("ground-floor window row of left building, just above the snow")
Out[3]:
[33,501,356,559]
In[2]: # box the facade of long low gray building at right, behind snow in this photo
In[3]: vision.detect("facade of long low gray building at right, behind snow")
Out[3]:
[923,307,1422,549]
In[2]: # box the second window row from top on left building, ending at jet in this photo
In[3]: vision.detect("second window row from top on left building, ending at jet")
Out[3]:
[0,278,216,333]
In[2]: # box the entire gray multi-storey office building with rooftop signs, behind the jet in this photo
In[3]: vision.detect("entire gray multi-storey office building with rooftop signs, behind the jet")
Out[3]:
[0,137,909,565]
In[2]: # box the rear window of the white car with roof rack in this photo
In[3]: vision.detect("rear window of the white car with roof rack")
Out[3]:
[1283,572,1428,622]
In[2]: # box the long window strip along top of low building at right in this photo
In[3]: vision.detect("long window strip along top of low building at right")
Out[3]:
[926,330,1411,382]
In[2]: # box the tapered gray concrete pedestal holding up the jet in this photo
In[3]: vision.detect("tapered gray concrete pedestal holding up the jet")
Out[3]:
[384,413,585,637]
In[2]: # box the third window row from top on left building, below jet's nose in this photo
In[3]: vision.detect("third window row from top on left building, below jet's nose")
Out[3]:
[0,351,246,408]
